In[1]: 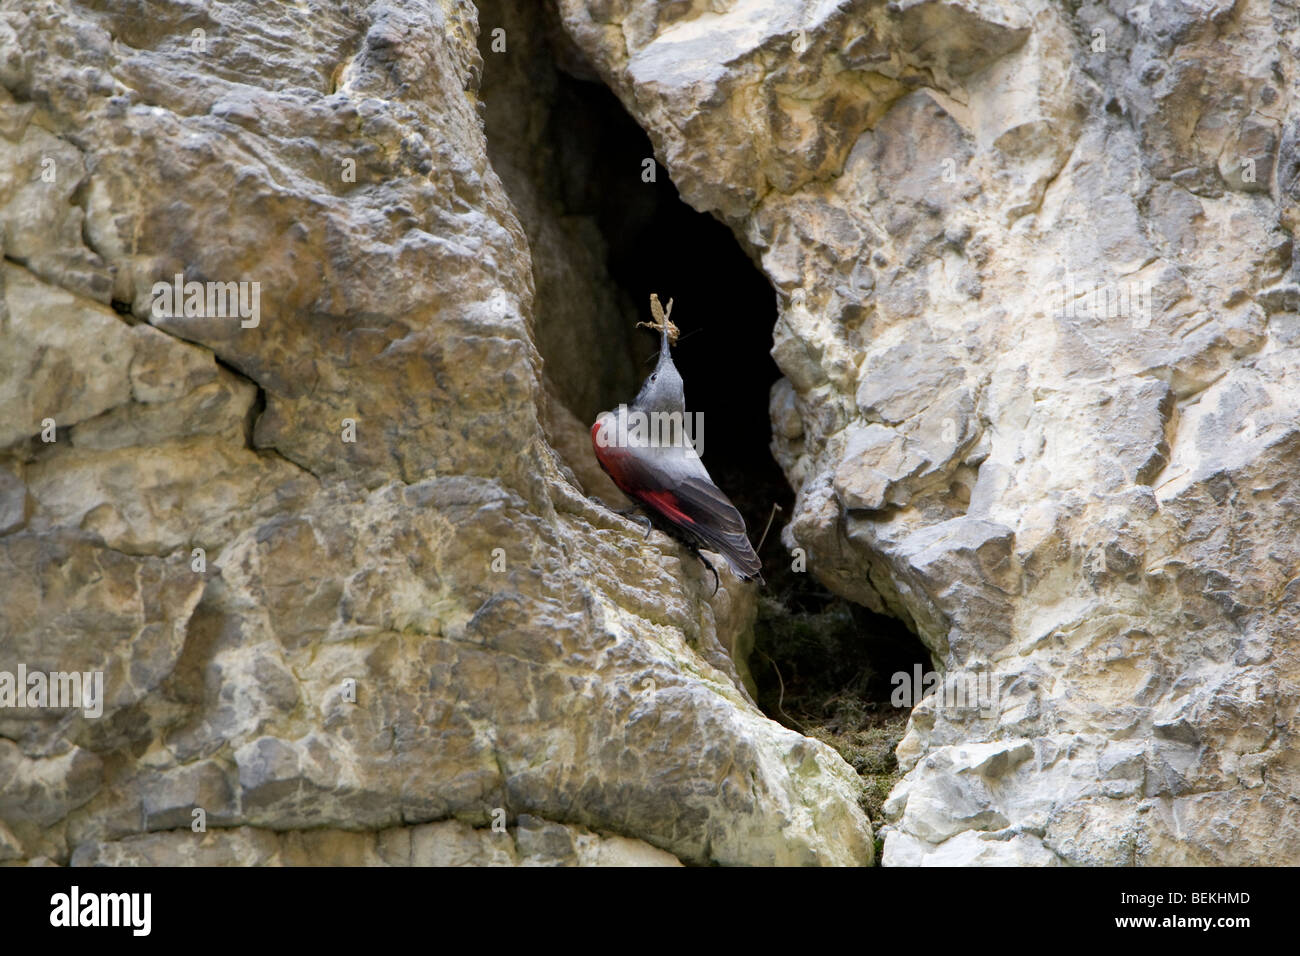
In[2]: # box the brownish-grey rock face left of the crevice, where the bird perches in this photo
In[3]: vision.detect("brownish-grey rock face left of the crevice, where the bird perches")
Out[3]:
[0,0,873,864]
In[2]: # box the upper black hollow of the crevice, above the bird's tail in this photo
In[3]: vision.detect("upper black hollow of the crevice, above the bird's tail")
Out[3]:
[549,73,784,478]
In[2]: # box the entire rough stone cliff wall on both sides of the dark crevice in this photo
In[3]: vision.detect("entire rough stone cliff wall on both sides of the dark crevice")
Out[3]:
[10,0,1300,865]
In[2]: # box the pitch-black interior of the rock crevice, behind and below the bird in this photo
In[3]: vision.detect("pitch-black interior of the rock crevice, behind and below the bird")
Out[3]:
[549,73,930,715]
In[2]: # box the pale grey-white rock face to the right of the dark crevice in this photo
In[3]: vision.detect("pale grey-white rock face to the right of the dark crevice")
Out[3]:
[560,0,1300,864]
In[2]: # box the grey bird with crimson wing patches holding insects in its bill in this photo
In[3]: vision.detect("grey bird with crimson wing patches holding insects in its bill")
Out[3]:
[592,295,763,594]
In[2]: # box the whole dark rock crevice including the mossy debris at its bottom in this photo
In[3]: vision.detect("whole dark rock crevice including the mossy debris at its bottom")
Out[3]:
[481,20,931,842]
